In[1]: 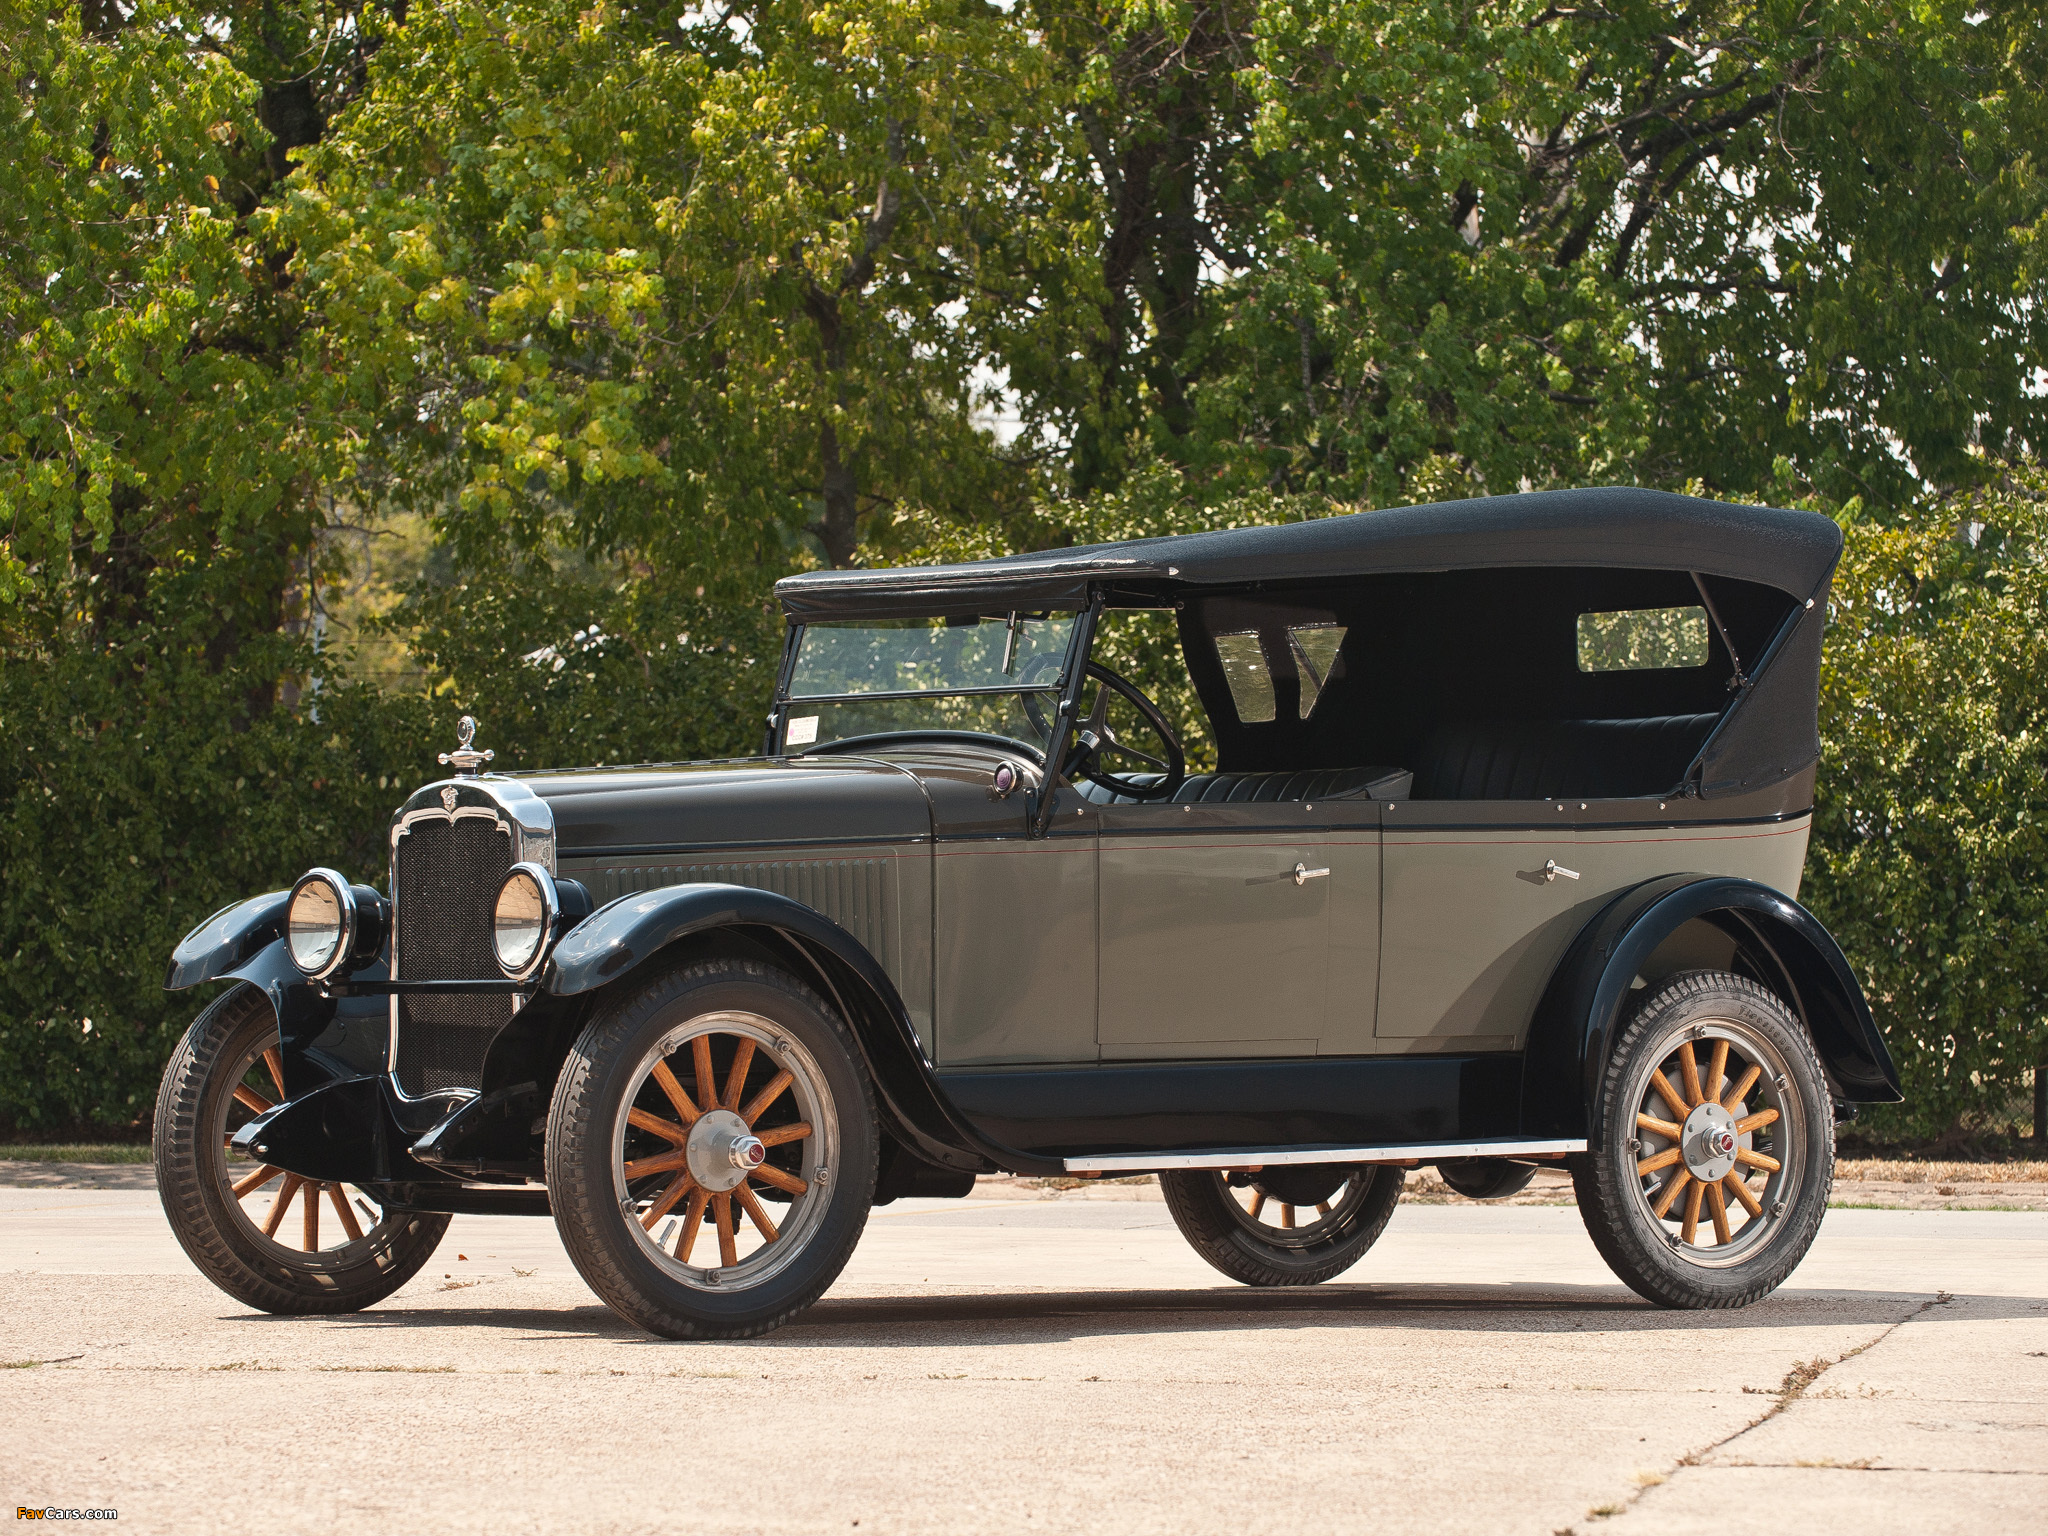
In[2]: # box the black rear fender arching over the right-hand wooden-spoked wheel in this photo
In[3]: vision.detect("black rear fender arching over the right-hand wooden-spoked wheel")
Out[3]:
[1522,874,1905,1151]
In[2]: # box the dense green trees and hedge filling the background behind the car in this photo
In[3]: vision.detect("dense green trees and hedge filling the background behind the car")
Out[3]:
[0,0,2048,1126]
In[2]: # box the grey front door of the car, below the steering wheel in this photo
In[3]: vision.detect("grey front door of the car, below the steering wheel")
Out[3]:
[1092,801,1333,1059]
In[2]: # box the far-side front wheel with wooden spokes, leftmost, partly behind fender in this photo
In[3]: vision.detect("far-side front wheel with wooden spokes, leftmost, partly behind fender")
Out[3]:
[156,985,449,1313]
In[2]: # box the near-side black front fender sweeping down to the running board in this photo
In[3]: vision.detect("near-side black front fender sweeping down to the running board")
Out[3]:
[541,885,1065,1176]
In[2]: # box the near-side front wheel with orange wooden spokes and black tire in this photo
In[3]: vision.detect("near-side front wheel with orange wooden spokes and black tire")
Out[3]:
[547,958,879,1339]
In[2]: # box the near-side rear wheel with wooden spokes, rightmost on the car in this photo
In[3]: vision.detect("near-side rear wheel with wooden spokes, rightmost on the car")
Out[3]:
[1569,971,1835,1309]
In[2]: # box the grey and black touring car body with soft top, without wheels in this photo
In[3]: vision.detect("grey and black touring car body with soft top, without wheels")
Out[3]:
[168,489,1898,1302]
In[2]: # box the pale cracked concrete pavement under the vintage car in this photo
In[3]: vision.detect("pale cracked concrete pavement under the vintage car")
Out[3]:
[0,1188,2048,1536]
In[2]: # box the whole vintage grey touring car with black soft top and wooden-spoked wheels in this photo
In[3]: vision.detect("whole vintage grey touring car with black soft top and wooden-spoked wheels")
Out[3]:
[156,487,1898,1337]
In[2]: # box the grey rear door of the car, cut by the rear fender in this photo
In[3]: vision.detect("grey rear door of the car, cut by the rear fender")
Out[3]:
[1374,801,1585,1051]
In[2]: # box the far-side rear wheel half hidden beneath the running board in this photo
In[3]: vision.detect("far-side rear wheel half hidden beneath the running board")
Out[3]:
[1159,1163,1407,1286]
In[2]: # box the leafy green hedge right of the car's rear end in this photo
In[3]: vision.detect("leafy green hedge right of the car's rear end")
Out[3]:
[1804,471,2048,1141]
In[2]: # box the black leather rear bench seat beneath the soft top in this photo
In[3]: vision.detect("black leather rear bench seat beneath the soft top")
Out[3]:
[1411,715,1720,801]
